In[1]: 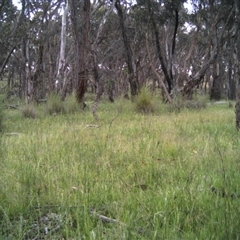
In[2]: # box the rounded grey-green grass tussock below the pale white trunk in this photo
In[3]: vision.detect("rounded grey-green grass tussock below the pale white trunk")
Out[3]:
[46,93,65,115]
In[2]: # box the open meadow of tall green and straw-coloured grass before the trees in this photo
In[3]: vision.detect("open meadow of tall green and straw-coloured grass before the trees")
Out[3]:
[0,96,240,240]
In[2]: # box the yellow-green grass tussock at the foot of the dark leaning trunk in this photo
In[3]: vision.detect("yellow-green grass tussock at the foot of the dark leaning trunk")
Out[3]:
[135,88,155,114]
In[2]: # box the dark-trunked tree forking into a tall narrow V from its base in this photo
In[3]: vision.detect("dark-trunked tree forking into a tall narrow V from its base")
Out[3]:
[133,0,188,101]
